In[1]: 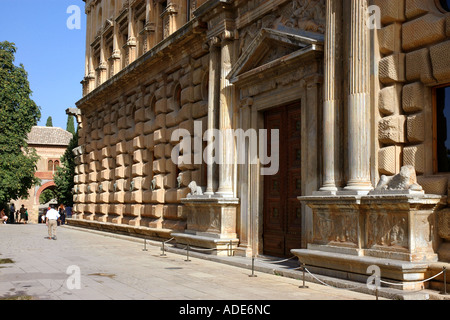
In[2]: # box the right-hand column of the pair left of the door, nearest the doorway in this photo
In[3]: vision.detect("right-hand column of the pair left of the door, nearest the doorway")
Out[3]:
[217,31,234,197]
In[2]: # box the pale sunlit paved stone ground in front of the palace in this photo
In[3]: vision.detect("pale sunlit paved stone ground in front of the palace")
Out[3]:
[0,224,375,300]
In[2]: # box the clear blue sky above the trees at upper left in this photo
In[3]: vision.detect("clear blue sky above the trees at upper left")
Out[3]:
[0,0,86,129]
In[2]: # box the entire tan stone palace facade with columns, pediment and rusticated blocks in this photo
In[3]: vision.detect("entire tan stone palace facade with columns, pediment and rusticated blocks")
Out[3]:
[71,0,450,290]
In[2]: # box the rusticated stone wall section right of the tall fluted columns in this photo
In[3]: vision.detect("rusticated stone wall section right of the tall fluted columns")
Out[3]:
[375,0,450,194]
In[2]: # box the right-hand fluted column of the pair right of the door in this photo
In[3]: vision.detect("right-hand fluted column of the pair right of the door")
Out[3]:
[345,0,373,193]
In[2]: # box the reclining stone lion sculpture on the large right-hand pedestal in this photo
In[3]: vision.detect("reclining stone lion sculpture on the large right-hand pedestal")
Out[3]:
[375,165,422,191]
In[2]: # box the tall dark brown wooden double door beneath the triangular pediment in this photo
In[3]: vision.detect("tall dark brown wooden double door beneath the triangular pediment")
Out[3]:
[263,103,302,257]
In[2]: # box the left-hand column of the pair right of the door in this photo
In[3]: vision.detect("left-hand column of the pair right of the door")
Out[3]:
[320,0,342,192]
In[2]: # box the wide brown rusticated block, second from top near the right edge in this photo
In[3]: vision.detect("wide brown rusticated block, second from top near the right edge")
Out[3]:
[402,14,445,51]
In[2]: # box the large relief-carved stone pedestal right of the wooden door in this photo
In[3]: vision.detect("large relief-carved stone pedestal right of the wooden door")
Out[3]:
[292,193,445,289]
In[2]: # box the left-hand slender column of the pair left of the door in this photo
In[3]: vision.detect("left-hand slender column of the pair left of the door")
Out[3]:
[205,37,220,195]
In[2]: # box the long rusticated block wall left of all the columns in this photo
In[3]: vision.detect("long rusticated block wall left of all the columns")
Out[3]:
[74,28,209,235]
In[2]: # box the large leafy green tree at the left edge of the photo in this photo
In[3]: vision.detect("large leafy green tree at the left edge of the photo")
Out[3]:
[0,41,41,204]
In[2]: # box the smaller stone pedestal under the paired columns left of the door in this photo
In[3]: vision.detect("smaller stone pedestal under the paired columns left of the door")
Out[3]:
[171,196,239,255]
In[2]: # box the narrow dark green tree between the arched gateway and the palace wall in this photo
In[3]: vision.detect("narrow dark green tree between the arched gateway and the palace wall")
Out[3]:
[53,133,78,207]
